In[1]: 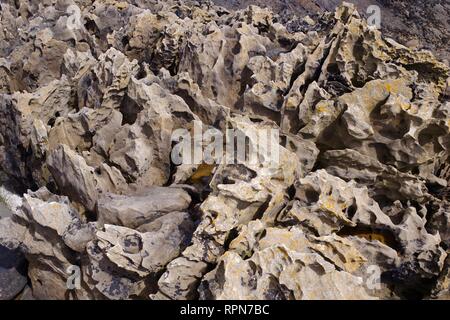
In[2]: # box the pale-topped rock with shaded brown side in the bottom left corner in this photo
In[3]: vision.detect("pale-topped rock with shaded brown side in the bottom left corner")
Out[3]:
[15,188,94,299]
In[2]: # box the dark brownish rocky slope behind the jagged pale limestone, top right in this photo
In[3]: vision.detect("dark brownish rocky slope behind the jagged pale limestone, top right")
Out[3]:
[213,0,450,63]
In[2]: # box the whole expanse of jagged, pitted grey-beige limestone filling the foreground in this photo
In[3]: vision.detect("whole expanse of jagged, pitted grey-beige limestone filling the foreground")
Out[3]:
[0,0,450,299]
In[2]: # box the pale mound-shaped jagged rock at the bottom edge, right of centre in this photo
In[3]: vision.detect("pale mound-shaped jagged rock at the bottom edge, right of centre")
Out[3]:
[200,228,371,300]
